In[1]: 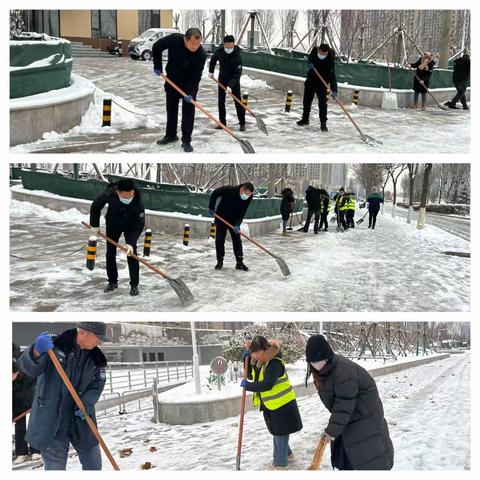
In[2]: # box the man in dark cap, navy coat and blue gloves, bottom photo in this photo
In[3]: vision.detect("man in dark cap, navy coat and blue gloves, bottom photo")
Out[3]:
[18,322,108,470]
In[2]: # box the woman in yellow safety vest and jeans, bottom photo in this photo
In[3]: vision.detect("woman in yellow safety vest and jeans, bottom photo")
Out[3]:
[240,336,303,470]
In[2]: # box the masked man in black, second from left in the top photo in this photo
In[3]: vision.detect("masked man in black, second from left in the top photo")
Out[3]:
[208,35,245,132]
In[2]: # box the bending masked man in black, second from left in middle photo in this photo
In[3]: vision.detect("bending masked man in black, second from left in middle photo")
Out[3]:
[208,182,255,272]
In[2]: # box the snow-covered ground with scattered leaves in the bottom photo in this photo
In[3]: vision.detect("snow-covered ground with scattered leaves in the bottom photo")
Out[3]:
[17,352,471,471]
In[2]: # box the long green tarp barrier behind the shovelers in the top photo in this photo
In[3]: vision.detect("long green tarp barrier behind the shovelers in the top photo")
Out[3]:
[242,51,453,90]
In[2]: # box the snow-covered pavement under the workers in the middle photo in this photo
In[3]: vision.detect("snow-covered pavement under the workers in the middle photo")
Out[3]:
[10,200,471,311]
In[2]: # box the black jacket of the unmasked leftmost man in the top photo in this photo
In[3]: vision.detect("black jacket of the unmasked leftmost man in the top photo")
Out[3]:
[152,33,207,95]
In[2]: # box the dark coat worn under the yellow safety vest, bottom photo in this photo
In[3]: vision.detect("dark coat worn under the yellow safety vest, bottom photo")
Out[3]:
[245,347,303,435]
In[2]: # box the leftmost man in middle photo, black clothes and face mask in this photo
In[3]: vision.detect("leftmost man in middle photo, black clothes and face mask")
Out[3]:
[90,178,145,296]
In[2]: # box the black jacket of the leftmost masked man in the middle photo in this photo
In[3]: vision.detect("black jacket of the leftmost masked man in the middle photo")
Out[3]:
[90,183,145,235]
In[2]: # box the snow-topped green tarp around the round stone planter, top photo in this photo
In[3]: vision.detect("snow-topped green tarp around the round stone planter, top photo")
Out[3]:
[10,40,72,98]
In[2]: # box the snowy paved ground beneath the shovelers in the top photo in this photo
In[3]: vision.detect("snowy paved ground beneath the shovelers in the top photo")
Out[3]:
[11,58,470,154]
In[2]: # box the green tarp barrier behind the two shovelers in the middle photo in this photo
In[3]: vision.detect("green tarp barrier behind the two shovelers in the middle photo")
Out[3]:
[21,170,303,219]
